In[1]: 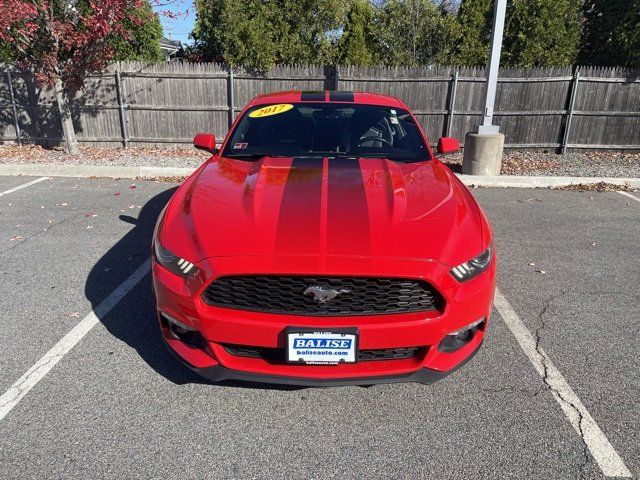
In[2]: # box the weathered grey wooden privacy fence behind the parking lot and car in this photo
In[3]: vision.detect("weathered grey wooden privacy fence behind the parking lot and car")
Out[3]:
[0,62,640,152]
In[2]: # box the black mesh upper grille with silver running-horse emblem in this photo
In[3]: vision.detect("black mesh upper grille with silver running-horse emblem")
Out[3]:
[202,276,444,316]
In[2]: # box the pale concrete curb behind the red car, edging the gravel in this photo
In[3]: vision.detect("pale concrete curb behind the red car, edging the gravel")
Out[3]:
[0,163,640,188]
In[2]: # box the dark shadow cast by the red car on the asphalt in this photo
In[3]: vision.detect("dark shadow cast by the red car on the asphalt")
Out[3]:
[85,187,300,390]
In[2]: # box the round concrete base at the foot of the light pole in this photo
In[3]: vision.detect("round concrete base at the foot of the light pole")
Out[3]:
[462,133,504,175]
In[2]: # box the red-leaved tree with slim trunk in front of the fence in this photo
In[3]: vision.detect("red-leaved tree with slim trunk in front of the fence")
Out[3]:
[0,0,165,154]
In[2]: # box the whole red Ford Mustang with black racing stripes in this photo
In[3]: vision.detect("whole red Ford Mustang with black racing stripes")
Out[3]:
[152,91,495,385]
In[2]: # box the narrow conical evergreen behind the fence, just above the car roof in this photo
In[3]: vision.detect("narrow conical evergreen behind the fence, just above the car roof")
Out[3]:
[338,0,376,67]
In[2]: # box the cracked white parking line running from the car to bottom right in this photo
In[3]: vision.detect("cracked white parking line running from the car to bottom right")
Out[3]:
[493,288,631,478]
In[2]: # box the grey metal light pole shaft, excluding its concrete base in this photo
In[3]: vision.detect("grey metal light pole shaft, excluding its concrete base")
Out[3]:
[476,0,507,134]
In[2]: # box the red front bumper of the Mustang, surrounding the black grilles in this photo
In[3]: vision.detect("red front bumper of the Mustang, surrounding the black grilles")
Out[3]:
[153,257,495,386]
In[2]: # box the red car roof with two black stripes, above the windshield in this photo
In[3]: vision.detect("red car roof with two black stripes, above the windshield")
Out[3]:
[248,90,407,109]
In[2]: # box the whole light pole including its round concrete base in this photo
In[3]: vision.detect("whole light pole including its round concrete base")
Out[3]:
[462,0,507,176]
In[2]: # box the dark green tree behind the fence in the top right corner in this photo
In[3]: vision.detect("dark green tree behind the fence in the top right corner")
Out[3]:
[580,0,640,68]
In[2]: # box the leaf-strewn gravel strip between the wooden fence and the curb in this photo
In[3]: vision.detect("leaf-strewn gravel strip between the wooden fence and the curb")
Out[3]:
[0,145,640,178]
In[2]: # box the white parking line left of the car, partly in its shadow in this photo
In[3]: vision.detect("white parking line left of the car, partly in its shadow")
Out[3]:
[0,260,149,421]
